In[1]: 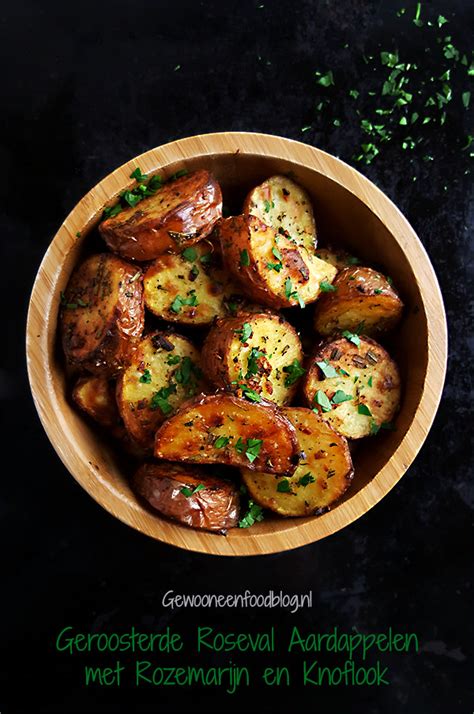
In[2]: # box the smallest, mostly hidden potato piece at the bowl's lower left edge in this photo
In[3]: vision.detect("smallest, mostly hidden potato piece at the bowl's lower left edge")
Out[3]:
[72,375,120,429]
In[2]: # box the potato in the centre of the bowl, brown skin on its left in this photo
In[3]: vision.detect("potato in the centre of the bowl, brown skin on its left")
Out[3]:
[201,312,304,404]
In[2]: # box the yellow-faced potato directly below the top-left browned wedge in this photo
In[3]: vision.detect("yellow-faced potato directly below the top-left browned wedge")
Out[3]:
[143,241,244,325]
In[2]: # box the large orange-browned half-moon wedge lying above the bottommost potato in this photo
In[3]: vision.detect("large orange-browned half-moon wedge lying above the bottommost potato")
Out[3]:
[155,393,298,474]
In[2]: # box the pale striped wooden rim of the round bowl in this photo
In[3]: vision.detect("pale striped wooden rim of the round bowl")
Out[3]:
[26,131,447,556]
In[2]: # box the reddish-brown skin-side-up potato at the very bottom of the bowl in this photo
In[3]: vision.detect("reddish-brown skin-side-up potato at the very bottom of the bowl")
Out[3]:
[132,462,239,534]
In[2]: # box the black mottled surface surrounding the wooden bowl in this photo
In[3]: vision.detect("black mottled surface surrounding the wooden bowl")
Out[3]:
[0,0,474,714]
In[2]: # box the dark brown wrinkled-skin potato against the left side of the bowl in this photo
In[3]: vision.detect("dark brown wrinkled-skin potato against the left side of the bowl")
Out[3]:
[60,253,145,376]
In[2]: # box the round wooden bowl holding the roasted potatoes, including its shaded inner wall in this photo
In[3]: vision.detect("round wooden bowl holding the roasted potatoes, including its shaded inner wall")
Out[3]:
[27,132,447,555]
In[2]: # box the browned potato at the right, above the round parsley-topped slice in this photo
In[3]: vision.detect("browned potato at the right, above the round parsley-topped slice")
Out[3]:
[314,267,403,335]
